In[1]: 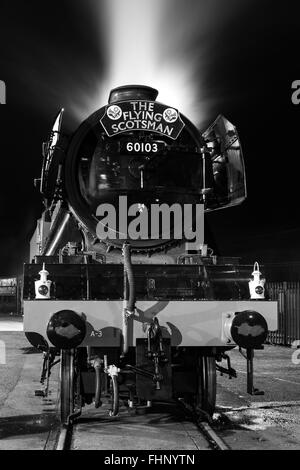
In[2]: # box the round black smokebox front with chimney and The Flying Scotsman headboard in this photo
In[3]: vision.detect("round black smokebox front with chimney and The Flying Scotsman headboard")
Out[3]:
[65,85,206,252]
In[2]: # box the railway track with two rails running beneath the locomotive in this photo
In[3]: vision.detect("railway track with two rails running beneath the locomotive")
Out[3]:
[46,403,229,452]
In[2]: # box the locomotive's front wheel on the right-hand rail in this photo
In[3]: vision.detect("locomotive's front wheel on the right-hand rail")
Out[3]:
[195,356,217,416]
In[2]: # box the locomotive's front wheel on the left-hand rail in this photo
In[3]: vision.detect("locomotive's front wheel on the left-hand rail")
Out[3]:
[60,349,76,424]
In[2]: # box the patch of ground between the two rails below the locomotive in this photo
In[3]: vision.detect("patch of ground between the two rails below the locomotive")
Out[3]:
[72,404,210,451]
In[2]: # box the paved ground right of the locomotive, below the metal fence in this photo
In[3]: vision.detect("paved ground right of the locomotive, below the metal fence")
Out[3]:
[214,345,300,450]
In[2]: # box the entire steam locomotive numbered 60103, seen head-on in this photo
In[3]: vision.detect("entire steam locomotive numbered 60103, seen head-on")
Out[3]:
[23,85,277,423]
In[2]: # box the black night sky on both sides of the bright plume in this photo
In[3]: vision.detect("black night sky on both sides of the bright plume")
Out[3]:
[0,0,300,275]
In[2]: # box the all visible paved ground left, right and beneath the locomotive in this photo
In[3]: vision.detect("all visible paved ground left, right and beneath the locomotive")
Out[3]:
[0,318,300,450]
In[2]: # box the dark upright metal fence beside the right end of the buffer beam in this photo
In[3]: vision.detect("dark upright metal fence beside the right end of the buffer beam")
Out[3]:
[266,281,300,345]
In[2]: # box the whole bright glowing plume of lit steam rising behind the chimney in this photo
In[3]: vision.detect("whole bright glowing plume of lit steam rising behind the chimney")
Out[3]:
[69,0,248,126]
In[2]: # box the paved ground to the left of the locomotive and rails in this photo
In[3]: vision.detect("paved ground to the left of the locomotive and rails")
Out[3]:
[0,317,57,450]
